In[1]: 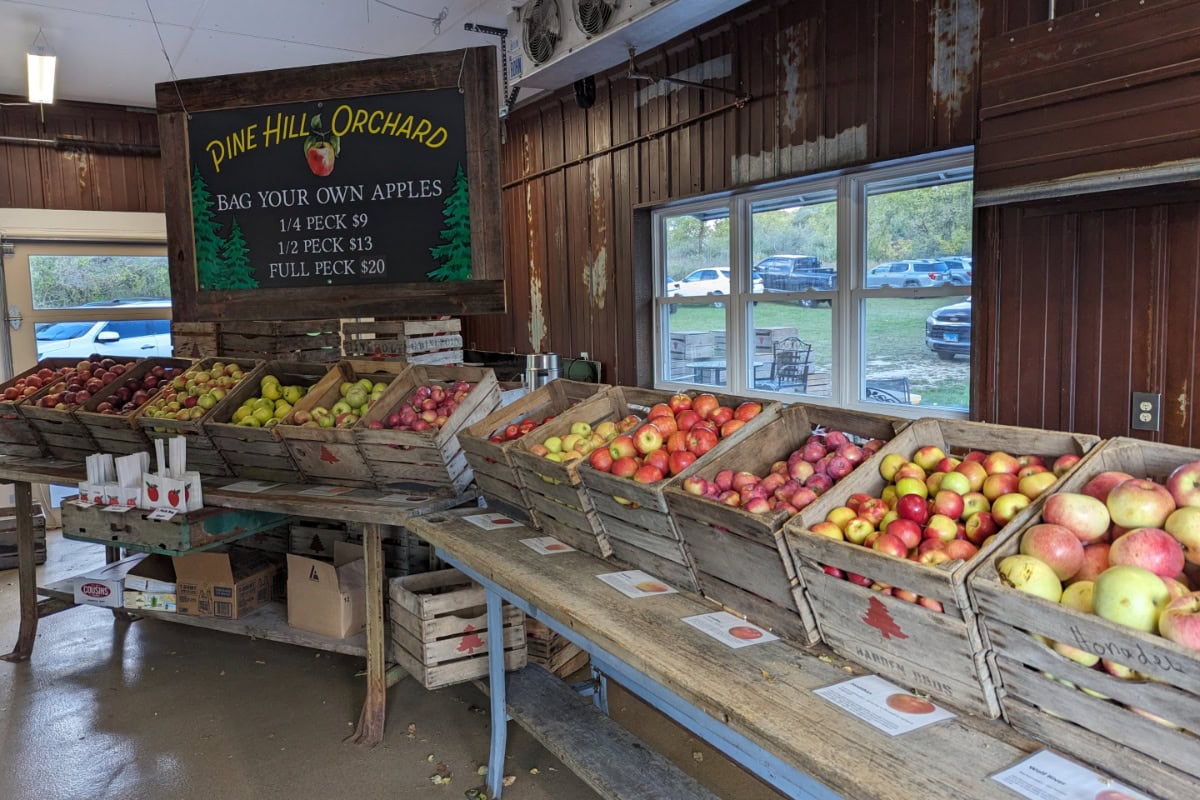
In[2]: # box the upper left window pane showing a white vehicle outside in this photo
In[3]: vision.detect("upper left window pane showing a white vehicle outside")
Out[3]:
[662,209,730,297]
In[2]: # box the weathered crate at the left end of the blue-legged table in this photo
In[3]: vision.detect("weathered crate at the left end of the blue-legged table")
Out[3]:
[458,379,608,523]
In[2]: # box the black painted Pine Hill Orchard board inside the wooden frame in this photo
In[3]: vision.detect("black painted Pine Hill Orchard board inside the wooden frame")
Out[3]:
[187,88,470,291]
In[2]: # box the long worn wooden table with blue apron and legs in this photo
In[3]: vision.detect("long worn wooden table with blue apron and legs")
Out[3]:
[408,513,1039,800]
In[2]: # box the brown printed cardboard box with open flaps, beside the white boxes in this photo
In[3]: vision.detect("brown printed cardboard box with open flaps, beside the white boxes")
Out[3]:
[173,551,278,619]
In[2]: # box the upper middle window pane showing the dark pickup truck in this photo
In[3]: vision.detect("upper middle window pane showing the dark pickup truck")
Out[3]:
[750,191,838,297]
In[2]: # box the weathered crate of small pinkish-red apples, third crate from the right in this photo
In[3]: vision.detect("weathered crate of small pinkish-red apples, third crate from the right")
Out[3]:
[665,404,907,644]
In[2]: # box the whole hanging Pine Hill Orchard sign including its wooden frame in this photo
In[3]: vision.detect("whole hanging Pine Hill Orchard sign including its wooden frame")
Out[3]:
[158,48,504,320]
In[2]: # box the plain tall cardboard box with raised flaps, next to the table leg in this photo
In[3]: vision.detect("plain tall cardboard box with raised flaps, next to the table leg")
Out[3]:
[288,542,367,639]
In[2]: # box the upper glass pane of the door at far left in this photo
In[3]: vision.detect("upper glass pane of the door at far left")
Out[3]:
[29,255,170,309]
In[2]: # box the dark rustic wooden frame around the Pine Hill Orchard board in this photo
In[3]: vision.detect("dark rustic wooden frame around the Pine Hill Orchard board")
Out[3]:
[155,47,505,321]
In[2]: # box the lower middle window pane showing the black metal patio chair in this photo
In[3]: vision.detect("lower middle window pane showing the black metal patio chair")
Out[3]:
[746,301,833,397]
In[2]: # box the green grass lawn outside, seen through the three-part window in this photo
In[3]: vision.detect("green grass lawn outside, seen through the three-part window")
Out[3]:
[670,297,971,409]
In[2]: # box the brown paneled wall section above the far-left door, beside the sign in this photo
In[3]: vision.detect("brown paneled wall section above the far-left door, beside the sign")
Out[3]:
[0,96,163,211]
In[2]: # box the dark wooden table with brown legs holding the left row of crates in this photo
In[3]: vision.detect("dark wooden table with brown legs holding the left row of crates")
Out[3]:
[0,457,474,747]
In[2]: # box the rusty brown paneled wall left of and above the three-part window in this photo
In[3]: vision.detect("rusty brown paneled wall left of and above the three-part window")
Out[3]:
[464,0,979,384]
